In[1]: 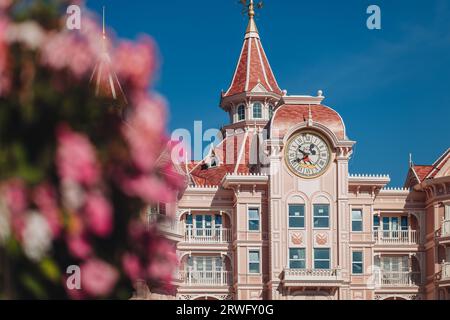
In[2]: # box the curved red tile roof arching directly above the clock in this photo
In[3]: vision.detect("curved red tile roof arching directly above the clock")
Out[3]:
[272,104,346,140]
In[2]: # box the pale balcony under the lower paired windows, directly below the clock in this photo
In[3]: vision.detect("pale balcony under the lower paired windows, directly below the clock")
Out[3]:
[283,269,342,287]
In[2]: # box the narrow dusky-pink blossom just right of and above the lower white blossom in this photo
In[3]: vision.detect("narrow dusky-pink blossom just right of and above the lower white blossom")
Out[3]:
[33,184,62,238]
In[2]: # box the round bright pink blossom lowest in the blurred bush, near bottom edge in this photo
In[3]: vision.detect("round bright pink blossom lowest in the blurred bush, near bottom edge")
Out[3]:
[81,258,119,297]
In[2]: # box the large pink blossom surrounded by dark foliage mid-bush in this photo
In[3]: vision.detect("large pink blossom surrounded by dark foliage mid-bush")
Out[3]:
[56,126,99,185]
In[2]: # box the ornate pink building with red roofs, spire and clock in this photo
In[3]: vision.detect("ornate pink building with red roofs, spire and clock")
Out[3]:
[150,1,450,300]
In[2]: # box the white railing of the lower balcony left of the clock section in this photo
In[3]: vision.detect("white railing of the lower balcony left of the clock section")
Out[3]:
[179,270,232,286]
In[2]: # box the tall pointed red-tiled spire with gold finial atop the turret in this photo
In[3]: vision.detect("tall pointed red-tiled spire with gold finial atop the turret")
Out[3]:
[222,0,282,98]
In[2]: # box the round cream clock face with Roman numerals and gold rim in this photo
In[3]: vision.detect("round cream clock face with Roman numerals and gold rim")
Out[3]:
[285,132,331,179]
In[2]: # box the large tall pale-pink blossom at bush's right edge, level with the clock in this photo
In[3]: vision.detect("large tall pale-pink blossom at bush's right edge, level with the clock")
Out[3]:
[122,97,165,171]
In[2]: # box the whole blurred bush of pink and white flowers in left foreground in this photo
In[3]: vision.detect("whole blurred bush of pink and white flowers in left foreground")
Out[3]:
[0,0,184,299]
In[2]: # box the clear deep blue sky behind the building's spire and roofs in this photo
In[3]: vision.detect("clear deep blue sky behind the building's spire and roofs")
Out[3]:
[87,0,450,186]
